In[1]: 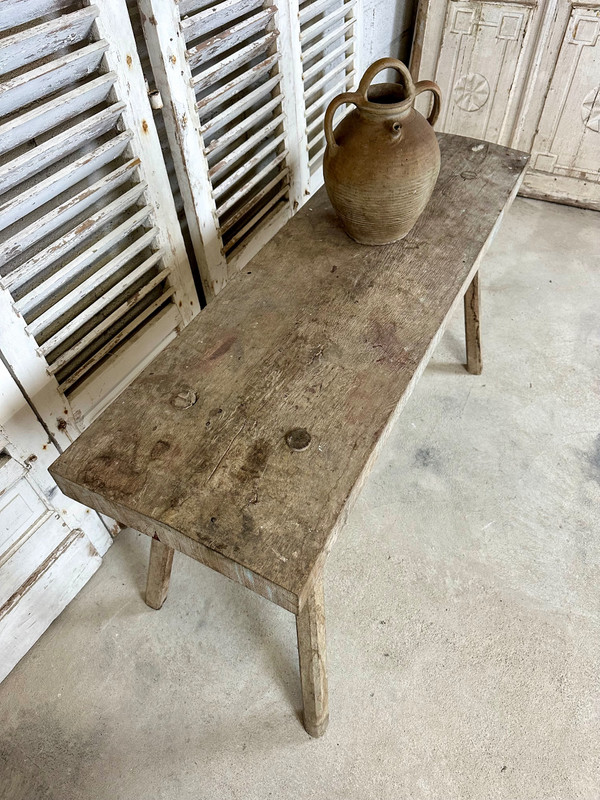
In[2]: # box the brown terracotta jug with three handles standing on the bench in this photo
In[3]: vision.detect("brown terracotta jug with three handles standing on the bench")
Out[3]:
[323,58,441,244]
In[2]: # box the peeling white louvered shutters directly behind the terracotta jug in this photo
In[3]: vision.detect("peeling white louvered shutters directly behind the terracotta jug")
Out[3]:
[138,0,358,299]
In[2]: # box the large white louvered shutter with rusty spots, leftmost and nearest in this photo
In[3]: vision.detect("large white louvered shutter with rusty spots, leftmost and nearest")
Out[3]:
[0,0,199,434]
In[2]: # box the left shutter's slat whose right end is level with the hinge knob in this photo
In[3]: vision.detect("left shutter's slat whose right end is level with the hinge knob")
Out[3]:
[0,102,125,194]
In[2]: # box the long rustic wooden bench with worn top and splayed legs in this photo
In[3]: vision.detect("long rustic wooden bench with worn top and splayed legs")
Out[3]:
[50,134,528,736]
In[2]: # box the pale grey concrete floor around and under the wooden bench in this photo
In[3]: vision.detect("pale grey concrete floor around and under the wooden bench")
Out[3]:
[0,199,600,800]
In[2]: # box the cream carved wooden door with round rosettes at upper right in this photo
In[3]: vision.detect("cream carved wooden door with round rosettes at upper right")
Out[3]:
[411,0,600,209]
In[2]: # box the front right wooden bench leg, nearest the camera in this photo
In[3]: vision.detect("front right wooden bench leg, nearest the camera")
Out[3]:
[296,575,329,736]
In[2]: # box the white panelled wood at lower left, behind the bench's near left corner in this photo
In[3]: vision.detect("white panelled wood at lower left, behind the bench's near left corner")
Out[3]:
[0,360,111,680]
